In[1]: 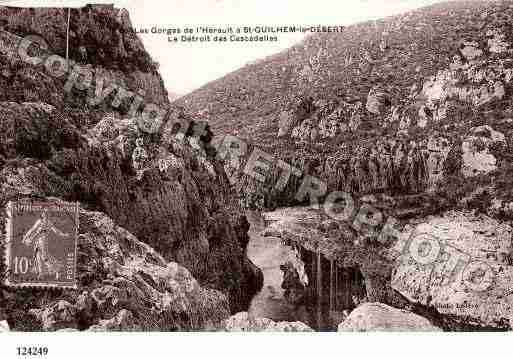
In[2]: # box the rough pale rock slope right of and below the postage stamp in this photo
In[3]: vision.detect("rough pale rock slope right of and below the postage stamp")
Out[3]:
[2,200,229,331]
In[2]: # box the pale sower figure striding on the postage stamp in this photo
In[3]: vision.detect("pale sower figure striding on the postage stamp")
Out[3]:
[23,209,69,279]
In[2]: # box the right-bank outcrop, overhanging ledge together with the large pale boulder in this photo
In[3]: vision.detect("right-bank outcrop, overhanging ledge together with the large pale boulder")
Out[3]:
[266,208,513,330]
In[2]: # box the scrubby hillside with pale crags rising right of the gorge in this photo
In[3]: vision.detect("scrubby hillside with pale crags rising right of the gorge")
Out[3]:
[176,1,513,217]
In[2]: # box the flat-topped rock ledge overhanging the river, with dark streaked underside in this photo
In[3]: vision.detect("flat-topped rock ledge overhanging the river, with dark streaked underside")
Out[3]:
[265,207,406,312]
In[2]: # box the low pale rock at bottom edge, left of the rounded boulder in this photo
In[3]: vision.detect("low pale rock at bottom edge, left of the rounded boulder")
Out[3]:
[225,312,313,332]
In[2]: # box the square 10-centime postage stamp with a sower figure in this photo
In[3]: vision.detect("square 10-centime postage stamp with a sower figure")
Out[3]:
[5,201,78,288]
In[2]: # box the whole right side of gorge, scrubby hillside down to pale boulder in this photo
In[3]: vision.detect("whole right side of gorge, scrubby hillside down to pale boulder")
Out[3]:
[178,1,513,330]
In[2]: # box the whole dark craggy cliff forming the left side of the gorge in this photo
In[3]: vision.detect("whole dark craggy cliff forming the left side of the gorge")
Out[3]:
[0,6,261,330]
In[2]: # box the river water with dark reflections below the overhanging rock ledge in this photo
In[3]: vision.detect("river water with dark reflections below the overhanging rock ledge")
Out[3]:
[247,212,365,331]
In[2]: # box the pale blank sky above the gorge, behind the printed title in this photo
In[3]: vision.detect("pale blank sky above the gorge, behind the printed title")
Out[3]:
[0,0,439,95]
